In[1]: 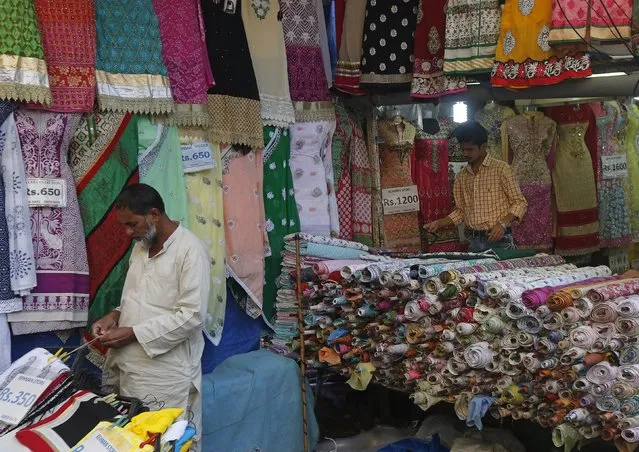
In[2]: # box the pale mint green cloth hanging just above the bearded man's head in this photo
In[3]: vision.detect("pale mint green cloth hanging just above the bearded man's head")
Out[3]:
[138,116,189,228]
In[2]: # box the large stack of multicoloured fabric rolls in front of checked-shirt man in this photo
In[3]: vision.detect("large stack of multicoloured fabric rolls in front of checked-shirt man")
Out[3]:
[264,235,639,449]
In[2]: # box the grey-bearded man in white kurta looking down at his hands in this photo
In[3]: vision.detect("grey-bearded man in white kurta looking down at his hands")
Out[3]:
[93,183,211,450]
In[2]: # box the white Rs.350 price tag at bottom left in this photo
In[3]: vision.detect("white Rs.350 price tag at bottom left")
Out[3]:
[0,374,51,425]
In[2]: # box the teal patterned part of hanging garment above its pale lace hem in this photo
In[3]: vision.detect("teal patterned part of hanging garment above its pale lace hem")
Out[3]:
[95,0,168,76]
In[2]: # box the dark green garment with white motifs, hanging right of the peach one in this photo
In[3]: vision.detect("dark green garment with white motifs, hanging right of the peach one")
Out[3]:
[262,127,300,321]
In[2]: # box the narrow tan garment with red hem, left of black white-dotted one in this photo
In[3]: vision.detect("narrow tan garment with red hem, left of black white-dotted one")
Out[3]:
[335,0,367,94]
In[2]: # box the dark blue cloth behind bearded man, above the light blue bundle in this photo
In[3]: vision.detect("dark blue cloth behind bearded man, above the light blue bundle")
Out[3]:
[202,286,264,374]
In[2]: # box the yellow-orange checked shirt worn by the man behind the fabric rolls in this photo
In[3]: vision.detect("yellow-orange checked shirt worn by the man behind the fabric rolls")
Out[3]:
[449,156,527,231]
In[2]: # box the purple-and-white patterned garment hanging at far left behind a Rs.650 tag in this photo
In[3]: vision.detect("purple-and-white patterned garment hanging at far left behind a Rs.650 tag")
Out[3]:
[9,110,89,334]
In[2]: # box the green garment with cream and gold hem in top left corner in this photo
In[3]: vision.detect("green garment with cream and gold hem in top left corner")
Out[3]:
[0,0,51,104]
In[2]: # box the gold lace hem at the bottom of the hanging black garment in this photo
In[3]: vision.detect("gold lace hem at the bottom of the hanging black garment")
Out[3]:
[208,94,264,148]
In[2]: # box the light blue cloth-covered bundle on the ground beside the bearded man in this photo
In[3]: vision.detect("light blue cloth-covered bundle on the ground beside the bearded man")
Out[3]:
[202,350,319,452]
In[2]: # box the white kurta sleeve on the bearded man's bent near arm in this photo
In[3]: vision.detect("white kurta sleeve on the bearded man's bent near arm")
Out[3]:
[133,248,211,358]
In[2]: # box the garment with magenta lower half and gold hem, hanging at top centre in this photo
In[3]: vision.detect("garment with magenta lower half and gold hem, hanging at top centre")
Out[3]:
[280,0,335,122]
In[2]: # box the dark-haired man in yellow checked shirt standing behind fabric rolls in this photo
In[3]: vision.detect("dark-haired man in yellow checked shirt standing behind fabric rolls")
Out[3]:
[424,121,528,252]
